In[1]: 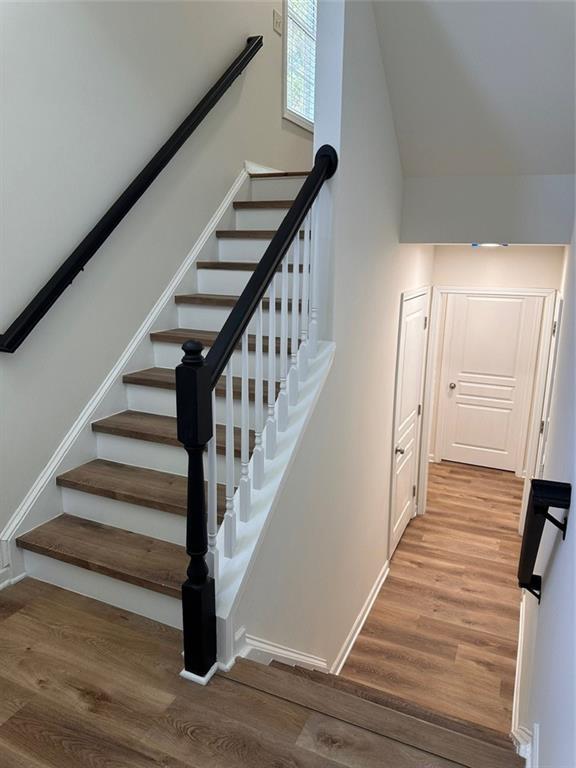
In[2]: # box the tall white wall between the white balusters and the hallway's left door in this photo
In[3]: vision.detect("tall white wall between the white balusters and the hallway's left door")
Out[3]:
[238,0,432,663]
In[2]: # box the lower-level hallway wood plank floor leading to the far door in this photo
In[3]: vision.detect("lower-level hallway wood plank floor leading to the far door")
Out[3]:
[341,462,523,733]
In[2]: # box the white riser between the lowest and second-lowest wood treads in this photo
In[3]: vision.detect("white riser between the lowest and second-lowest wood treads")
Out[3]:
[62,488,186,546]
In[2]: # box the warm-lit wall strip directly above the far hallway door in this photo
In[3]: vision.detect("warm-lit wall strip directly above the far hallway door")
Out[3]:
[433,244,566,289]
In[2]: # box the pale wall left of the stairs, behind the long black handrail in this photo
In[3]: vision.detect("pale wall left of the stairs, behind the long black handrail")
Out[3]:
[0,0,312,528]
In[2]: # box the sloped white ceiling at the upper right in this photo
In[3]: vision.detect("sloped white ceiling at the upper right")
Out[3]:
[374,0,575,177]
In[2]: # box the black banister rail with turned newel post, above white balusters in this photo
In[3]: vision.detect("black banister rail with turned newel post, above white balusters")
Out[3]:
[176,144,338,680]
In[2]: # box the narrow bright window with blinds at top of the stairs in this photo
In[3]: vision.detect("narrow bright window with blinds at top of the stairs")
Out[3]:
[285,0,316,127]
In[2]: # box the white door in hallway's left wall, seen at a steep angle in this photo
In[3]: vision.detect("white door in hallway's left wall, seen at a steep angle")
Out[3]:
[389,289,429,556]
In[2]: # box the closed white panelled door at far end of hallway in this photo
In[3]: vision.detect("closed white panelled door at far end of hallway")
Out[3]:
[438,292,544,471]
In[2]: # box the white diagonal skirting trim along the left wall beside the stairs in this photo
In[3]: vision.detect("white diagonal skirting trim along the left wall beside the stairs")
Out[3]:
[0,168,249,552]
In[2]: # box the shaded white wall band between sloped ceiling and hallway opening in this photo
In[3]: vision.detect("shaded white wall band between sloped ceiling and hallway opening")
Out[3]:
[400,174,574,243]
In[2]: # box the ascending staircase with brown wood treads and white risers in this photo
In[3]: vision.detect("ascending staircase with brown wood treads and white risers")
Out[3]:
[17,172,306,626]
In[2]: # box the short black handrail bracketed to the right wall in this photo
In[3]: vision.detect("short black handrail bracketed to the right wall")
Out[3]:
[518,480,572,602]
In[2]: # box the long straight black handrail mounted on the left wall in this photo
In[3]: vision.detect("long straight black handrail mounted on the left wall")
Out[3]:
[0,35,264,352]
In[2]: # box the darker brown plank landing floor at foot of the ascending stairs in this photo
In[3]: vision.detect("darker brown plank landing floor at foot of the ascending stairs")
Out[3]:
[0,579,476,768]
